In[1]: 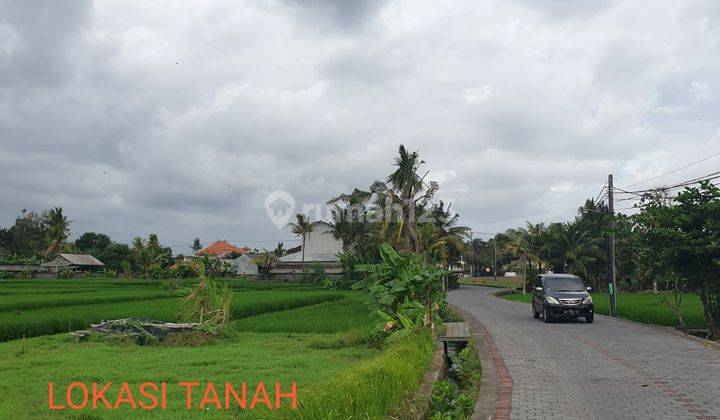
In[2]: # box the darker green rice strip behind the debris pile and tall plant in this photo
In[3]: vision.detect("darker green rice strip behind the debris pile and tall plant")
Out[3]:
[0,290,343,341]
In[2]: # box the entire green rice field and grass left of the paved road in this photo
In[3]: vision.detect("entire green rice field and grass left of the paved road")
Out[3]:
[0,281,432,418]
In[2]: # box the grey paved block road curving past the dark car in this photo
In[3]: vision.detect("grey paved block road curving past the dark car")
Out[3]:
[448,286,720,419]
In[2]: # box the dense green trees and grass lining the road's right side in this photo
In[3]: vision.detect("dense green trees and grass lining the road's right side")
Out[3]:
[466,179,720,338]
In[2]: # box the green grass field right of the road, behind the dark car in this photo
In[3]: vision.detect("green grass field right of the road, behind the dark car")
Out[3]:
[503,293,706,327]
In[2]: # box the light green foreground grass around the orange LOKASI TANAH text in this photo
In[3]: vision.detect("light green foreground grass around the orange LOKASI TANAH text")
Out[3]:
[0,332,382,418]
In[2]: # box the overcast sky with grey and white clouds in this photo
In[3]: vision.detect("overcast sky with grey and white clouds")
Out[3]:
[0,0,720,252]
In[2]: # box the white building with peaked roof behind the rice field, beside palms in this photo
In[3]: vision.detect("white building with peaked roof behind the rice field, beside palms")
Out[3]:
[272,221,343,276]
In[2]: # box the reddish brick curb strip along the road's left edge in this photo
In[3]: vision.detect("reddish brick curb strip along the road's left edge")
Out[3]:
[450,304,512,419]
